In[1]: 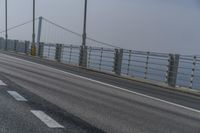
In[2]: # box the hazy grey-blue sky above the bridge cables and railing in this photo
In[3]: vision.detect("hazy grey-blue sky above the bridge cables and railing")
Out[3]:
[0,0,200,54]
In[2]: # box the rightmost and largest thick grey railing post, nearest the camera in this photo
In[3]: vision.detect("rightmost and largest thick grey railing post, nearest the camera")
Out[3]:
[167,54,180,87]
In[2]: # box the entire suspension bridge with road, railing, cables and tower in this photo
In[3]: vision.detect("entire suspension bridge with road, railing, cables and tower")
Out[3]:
[0,17,200,133]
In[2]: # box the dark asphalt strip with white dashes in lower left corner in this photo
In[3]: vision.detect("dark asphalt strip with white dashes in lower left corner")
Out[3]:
[0,74,103,133]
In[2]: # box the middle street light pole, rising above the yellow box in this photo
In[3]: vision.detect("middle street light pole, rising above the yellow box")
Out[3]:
[31,0,36,56]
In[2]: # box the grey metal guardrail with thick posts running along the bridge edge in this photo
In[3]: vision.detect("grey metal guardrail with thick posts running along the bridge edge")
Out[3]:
[0,38,200,89]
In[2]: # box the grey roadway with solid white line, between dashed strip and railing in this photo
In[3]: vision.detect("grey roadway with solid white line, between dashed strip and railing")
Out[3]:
[0,51,200,133]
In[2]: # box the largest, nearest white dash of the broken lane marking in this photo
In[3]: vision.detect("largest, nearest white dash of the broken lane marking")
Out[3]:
[31,110,64,128]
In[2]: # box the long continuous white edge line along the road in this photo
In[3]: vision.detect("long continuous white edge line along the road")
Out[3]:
[3,54,200,113]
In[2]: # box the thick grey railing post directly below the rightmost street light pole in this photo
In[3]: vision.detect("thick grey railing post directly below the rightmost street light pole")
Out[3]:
[79,45,87,67]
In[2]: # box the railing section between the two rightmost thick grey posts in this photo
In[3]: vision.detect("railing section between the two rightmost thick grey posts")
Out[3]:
[122,50,170,82]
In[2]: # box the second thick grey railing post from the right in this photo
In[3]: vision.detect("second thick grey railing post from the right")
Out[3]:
[114,49,123,75]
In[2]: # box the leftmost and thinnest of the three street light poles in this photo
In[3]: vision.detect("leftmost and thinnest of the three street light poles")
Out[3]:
[5,0,8,50]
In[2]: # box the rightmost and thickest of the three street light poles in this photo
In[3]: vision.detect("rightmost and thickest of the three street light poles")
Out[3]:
[82,0,87,46]
